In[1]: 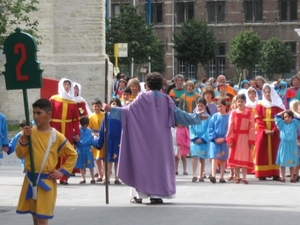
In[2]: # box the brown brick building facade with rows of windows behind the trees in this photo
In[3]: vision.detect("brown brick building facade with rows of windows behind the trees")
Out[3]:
[110,0,300,79]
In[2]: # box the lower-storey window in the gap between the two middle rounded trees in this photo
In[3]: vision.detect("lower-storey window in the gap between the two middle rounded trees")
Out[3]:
[208,43,226,78]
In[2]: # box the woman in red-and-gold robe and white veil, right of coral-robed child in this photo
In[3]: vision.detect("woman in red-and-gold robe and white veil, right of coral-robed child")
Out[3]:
[255,84,285,180]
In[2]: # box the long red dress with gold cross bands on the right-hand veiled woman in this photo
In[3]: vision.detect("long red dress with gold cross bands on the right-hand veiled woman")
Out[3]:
[255,102,283,178]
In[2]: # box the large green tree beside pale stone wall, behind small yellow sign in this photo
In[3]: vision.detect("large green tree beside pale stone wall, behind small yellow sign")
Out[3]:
[106,4,165,73]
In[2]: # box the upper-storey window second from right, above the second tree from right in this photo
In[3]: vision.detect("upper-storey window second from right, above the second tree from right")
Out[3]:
[244,0,263,23]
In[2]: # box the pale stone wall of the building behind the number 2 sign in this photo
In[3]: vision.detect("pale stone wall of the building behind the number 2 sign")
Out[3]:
[0,0,112,120]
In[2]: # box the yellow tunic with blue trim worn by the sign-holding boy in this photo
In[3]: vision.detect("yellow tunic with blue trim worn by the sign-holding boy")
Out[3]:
[16,127,77,219]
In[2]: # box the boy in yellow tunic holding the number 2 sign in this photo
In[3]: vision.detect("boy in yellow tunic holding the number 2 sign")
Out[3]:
[16,99,77,225]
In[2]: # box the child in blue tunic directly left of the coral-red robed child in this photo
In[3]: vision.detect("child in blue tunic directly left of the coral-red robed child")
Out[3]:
[208,100,229,183]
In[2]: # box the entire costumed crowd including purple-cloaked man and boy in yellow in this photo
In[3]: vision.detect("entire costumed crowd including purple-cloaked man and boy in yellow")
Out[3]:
[0,73,300,224]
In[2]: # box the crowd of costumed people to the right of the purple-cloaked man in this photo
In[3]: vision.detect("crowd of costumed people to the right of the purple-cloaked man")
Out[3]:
[166,73,300,184]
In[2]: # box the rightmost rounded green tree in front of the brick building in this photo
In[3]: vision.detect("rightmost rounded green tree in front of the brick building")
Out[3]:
[258,37,294,79]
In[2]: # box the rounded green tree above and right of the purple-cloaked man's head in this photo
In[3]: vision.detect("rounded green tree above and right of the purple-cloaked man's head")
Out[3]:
[173,19,218,74]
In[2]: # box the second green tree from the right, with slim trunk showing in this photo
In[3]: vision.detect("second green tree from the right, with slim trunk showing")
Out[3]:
[228,29,261,83]
